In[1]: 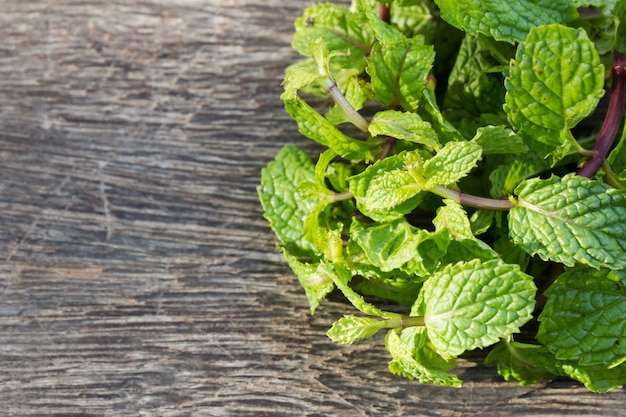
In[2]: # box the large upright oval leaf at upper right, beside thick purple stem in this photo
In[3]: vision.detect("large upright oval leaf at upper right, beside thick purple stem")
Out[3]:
[505,25,604,154]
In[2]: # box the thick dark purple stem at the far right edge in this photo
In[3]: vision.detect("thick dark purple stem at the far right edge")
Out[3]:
[578,51,626,177]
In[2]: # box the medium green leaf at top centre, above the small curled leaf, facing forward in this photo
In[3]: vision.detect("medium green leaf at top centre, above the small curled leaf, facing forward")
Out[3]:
[367,28,435,111]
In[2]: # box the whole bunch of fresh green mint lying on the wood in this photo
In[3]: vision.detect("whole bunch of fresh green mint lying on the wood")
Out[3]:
[258,0,626,392]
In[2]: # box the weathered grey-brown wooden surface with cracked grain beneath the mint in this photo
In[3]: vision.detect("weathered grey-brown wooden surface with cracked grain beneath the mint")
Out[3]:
[0,0,626,416]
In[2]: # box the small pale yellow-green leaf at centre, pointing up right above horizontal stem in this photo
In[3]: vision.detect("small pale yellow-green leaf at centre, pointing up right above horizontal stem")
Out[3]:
[424,142,482,189]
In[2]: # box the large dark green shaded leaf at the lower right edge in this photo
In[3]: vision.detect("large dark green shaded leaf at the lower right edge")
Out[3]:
[537,268,626,368]
